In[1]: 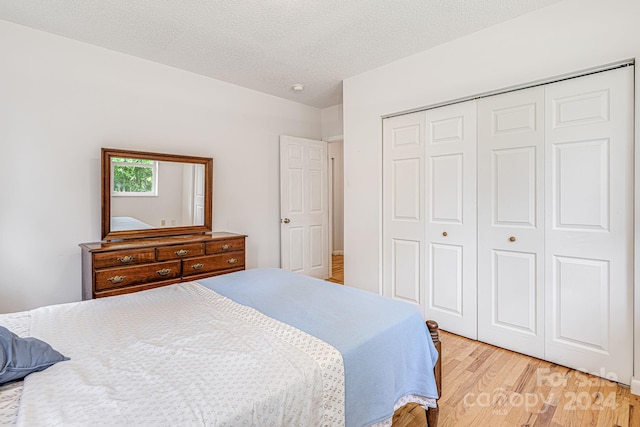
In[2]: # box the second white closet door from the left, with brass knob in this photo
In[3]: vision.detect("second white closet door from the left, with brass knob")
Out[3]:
[425,101,478,339]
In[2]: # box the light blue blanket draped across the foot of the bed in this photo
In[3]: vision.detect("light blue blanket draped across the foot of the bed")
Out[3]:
[198,268,438,427]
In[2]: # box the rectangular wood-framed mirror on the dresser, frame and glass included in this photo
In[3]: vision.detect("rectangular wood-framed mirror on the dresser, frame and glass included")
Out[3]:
[102,148,213,240]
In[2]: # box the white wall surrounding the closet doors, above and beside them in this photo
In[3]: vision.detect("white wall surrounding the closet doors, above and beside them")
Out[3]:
[343,0,640,392]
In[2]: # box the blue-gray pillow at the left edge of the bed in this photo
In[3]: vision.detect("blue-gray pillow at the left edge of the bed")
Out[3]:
[0,326,69,385]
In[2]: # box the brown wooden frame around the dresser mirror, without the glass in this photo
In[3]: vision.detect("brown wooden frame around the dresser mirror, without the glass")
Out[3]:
[102,148,213,240]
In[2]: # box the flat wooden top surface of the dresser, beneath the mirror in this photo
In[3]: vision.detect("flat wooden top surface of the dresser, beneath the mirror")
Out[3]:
[80,231,247,252]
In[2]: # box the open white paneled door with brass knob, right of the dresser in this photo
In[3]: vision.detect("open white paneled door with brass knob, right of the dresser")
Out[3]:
[280,135,329,279]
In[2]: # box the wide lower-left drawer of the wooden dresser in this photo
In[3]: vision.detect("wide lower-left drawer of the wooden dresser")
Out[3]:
[95,261,182,292]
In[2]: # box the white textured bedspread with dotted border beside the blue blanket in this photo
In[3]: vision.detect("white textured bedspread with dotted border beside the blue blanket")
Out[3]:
[18,283,344,426]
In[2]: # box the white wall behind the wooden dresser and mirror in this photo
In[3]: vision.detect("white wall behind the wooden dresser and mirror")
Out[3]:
[0,21,322,312]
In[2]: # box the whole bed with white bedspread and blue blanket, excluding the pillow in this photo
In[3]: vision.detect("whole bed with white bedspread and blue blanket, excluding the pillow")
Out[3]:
[0,268,440,427]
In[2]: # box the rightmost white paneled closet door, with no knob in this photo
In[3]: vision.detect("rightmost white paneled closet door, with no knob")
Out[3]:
[545,67,633,384]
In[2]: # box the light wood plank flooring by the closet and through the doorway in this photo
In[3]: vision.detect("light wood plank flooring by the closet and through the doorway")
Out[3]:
[330,255,640,427]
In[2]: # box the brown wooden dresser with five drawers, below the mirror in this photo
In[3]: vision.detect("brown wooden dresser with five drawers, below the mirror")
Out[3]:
[80,232,246,300]
